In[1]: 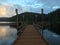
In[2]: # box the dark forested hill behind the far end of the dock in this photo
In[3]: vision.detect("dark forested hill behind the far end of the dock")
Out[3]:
[11,12,47,22]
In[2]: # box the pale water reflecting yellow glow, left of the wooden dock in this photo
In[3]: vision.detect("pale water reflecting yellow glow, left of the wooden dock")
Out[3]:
[0,25,17,45]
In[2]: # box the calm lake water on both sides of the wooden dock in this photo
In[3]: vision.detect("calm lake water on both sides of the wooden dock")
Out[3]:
[0,25,60,45]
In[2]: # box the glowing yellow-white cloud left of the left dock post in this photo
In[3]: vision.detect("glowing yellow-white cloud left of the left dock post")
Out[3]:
[0,4,15,17]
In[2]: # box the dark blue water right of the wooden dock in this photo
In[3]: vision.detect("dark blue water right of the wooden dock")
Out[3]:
[39,29,60,45]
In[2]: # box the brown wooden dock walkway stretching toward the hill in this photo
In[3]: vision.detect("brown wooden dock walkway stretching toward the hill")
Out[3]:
[13,25,48,45]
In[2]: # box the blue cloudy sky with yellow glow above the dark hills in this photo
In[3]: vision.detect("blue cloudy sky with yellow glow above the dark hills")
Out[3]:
[0,0,60,17]
